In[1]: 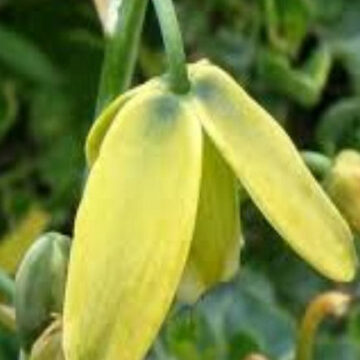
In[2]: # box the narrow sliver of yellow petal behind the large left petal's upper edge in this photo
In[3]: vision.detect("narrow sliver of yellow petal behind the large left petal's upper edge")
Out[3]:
[85,79,162,167]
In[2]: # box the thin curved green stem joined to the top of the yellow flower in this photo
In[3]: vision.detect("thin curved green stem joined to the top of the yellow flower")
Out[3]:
[153,0,190,94]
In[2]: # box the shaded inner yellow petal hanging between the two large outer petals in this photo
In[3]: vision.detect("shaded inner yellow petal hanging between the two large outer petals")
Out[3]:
[178,137,242,303]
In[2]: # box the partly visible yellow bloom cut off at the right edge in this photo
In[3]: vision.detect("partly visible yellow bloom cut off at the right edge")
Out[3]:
[324,150,360,231]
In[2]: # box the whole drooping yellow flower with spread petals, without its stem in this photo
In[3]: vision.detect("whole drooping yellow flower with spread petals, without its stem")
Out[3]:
[64,62,356,360]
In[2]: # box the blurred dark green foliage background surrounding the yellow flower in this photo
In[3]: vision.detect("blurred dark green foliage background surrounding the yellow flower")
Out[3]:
[0,0,360,360]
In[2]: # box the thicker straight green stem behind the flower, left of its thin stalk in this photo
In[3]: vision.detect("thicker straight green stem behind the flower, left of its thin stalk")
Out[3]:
[95,0,148,117]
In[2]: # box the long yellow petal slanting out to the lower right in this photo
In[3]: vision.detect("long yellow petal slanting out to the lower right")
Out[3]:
[192,65,357,281]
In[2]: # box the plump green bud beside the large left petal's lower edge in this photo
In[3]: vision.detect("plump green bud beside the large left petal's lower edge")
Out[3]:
[15,233,70,351]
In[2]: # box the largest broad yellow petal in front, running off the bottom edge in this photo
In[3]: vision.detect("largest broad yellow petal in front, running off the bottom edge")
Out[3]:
[64,91,202,360]
